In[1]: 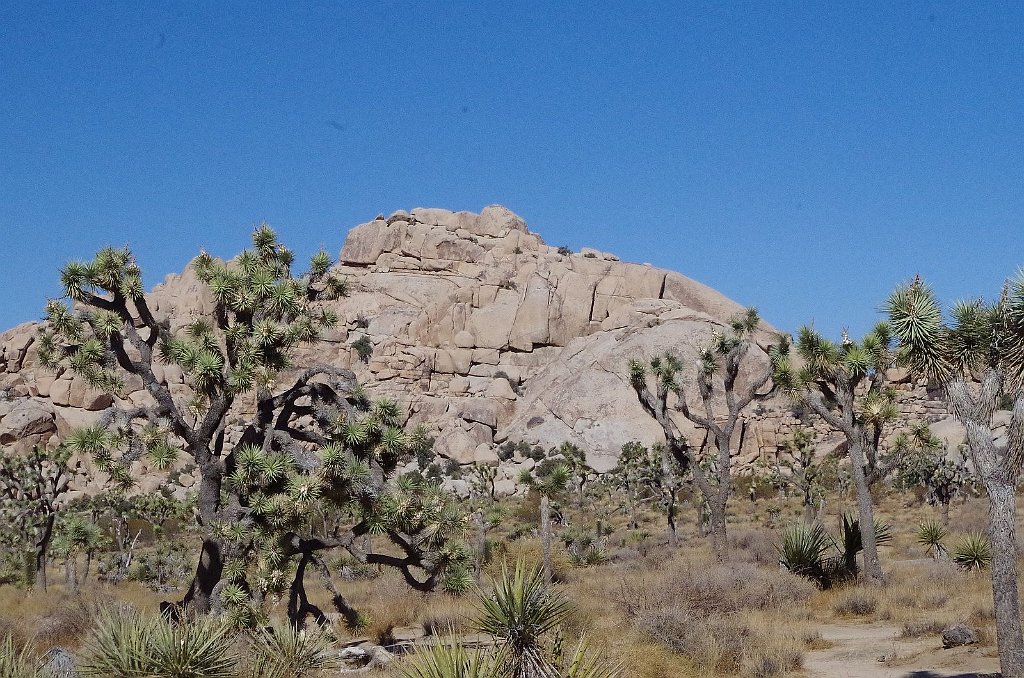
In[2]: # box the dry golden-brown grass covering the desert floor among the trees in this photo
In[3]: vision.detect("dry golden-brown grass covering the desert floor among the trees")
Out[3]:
[0,485,1019,678]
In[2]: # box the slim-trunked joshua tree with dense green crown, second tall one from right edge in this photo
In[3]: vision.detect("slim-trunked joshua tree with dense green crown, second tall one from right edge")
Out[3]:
[775,323,898,583]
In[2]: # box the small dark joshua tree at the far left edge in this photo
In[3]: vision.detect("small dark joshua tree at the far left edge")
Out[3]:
[0,446,74,591]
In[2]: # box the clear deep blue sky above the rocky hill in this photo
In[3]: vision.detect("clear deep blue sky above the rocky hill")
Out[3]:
[0,0,1024,334]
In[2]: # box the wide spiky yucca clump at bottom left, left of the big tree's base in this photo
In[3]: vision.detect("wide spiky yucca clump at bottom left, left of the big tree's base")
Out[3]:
[80,610,238,678]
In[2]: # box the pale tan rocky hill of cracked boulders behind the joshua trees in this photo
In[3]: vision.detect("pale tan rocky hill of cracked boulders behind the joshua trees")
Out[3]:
[0,206,954,499]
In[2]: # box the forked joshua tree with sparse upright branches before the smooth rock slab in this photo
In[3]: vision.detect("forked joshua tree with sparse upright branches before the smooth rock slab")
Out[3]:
[629,308,772,560]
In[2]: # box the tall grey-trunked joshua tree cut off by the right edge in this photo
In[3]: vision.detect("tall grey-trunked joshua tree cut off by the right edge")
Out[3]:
[886,273,1024,678]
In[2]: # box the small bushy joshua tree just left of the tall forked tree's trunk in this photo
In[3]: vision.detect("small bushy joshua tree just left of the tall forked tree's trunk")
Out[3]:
[614,441,686,546]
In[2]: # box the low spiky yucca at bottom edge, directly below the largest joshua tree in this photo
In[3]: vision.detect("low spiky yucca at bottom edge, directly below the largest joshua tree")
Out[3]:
[251,623,339,678]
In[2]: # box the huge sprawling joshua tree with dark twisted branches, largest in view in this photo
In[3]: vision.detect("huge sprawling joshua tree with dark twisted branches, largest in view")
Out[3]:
[39,224,462,620]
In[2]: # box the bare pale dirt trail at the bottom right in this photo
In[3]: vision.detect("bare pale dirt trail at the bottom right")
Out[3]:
[804,624,999,678]
